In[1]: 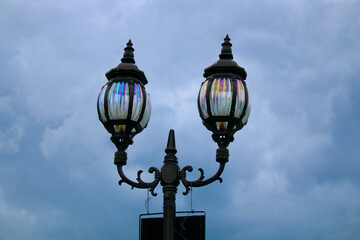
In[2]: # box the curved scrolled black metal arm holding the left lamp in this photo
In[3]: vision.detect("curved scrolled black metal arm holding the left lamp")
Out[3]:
[114,151,161,196]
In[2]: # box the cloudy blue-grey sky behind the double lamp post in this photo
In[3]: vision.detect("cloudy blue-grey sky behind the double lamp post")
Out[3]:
[0,0,360,240]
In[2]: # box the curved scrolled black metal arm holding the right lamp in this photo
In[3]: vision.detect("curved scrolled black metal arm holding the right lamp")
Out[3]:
[180,148,229,195]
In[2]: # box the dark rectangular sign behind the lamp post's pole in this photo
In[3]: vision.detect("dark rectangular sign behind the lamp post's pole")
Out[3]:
[140,213,205,240]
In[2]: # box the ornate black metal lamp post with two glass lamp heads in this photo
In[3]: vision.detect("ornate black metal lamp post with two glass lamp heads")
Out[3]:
[97,35,251,240]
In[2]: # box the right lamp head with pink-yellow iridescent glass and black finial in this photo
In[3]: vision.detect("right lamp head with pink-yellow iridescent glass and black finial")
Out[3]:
[198,35,251,148]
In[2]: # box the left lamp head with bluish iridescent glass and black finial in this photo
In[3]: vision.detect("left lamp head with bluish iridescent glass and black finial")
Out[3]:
[97,40,151,151]
